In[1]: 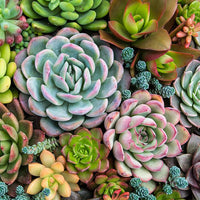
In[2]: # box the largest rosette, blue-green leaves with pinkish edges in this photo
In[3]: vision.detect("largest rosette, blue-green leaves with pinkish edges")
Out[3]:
[14,28,124,136]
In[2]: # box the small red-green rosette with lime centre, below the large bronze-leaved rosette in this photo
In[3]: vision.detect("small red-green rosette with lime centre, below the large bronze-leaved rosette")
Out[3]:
[146,50,193,82]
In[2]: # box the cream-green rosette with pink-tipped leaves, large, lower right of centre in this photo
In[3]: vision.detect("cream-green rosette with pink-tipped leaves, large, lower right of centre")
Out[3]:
[103,90,190,192]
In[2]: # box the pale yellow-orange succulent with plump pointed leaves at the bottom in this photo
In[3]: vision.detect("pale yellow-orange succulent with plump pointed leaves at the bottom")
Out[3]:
[27,150,80,200]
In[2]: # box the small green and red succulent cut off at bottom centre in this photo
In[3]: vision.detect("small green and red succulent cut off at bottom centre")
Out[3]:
[87,169,130,200]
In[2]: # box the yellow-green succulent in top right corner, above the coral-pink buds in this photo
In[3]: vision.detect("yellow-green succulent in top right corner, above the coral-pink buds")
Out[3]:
[176,0,200,24]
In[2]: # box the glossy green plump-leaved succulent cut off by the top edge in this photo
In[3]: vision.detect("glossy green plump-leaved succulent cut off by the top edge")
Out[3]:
[21,0,110,32]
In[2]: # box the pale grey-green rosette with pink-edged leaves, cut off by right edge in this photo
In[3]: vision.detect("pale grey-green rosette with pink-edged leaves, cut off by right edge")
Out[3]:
[170,60,200,128]
